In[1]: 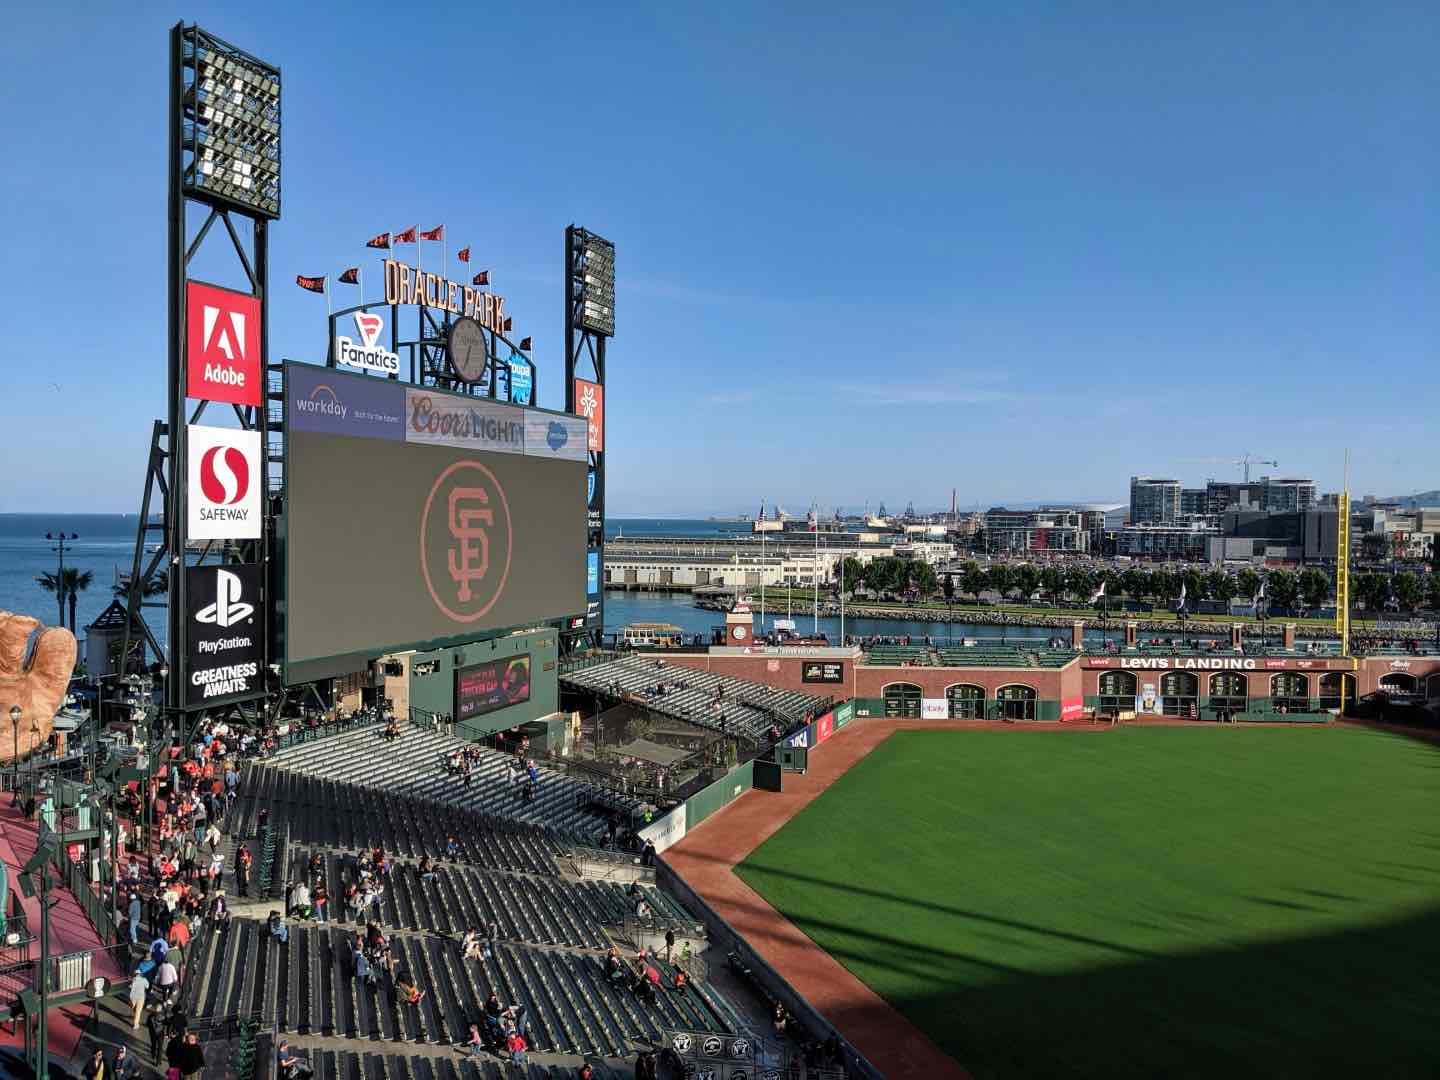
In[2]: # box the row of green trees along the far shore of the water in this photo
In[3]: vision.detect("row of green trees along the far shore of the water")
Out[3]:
[837,559,1440,611]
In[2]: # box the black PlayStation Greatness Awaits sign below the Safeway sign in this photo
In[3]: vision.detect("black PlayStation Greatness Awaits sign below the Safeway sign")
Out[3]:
[186,563,265,707]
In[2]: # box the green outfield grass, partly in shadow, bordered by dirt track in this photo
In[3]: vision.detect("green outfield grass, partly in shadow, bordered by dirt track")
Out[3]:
[737,727,1440,1077]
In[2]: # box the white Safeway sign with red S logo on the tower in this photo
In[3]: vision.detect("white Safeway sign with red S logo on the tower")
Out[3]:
[186,423,265,540]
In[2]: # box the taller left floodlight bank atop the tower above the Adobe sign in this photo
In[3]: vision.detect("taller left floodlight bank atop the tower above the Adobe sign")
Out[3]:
[176,26,281,219]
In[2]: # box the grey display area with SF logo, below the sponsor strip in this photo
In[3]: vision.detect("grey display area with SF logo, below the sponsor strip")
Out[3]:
[284,431,586,683]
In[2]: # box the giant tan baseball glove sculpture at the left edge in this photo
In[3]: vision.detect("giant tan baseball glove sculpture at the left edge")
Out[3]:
[0,611,76,762]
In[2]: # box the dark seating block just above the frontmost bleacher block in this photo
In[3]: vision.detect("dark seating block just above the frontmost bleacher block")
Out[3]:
[288,845,698,949]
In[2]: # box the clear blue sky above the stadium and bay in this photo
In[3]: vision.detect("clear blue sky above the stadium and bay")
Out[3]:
[0,0,1440,514]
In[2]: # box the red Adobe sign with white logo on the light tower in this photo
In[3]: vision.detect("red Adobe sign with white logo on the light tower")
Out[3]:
[184,281,264,405]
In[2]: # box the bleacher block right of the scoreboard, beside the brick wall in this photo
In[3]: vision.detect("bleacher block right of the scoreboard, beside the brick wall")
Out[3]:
[562,655,821,742]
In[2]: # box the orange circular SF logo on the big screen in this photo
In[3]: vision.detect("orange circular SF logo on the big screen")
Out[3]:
[419,459,513,624]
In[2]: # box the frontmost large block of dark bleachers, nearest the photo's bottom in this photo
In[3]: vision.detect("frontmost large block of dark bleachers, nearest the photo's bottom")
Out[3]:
[187,917,744,1057]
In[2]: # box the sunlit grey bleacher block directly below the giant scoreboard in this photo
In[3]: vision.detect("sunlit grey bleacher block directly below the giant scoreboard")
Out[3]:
[269,727,641,841]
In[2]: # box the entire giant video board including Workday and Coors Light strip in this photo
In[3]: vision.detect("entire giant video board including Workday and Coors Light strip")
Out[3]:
[282,364,586,683]
